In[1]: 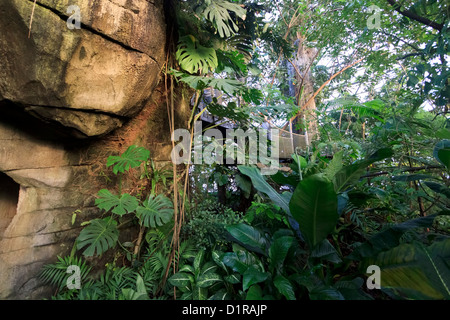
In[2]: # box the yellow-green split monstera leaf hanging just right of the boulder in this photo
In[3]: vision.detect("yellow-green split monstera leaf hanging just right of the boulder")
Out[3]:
[176,35,218,73]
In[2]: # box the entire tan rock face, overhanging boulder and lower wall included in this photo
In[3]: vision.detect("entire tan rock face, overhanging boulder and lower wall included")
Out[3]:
[0,0,189,299]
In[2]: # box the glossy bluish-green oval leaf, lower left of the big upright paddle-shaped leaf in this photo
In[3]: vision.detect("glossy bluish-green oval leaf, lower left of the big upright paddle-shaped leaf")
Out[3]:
[226,223,267,254]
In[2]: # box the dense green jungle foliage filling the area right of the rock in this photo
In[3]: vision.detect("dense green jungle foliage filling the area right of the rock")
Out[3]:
[40,0,450,300]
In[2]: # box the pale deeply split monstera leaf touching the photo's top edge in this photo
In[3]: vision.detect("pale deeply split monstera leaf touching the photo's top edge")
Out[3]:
[203,0,247,38]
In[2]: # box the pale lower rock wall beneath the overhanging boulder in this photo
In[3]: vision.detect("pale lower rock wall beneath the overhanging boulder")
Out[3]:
[0,118,89,299]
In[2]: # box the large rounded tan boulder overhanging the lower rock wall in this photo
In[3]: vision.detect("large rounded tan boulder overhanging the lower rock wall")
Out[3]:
[0,0,166,137]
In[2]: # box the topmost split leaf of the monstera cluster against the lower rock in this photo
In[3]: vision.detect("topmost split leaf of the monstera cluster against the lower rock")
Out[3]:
[106,145,150,174]
